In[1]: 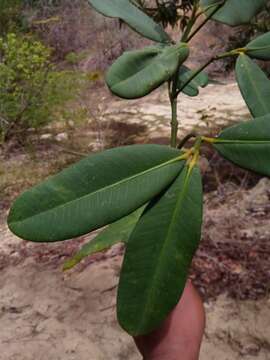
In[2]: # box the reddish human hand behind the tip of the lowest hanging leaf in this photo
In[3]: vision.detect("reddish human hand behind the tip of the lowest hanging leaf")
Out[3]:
[134,281,205,360]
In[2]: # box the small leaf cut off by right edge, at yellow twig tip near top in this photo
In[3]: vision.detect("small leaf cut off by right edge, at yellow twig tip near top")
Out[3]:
[245,32,270,60]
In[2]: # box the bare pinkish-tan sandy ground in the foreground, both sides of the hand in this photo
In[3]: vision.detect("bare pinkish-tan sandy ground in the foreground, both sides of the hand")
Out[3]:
[0,228,270,360]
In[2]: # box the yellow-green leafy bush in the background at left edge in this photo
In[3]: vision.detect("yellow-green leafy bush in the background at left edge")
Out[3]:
[0,33,84,141]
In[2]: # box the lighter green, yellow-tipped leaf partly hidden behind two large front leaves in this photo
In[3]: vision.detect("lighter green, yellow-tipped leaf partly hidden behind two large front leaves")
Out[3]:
[63,206,145,271]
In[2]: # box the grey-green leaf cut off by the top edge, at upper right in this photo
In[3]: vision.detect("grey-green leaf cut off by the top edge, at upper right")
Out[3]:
[200,0,267,26]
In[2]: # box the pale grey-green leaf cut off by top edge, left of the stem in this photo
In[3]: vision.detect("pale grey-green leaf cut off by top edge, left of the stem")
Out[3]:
[88,0,171,43]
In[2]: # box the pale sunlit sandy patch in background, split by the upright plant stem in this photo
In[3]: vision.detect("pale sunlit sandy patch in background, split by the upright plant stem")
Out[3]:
[104,80,250,140]
